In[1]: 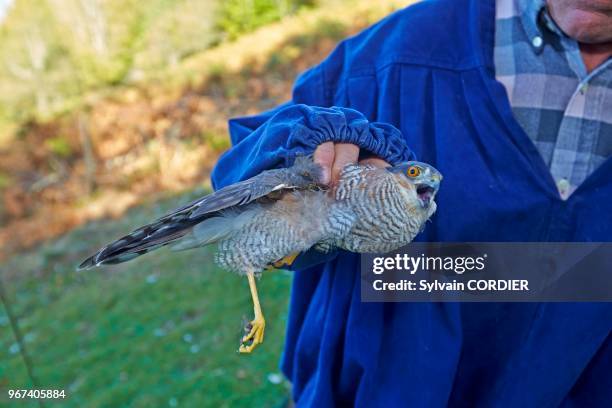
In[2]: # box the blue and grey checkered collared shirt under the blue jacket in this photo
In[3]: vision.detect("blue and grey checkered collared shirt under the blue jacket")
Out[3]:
[494,0,612,199]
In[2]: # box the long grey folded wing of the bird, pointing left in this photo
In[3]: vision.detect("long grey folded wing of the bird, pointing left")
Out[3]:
[79,157,324,269]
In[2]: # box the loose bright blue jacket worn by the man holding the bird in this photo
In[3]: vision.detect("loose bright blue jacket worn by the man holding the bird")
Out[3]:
[213,0,612,408]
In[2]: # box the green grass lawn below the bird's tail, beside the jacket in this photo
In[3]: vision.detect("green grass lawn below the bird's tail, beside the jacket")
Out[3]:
[0,190,290,407]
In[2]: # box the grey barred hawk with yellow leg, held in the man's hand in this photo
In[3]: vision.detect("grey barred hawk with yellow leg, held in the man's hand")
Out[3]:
[79,155,442,353]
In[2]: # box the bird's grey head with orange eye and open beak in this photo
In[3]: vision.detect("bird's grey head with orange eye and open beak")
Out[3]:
[387,161,442,210]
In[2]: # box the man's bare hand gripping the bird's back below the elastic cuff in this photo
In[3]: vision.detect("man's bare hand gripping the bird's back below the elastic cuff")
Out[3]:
[314,142,390,185]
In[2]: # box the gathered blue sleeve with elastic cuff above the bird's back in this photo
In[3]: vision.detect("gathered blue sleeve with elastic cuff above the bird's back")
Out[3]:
[212,103,410,188]
